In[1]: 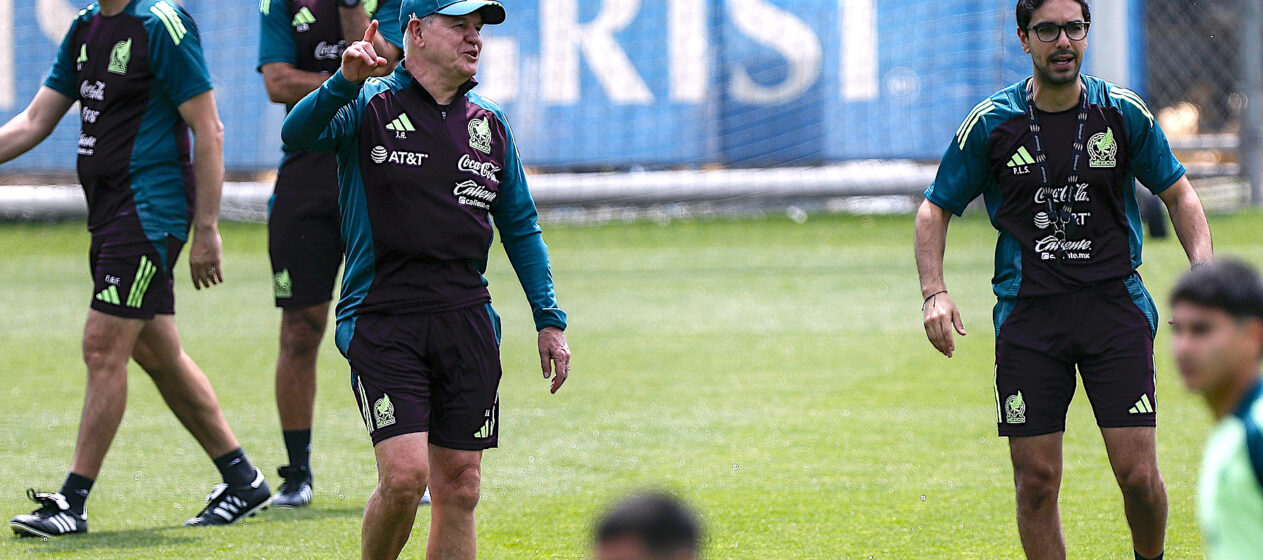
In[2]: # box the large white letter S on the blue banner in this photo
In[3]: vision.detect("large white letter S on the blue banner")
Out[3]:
[727,0,823,105]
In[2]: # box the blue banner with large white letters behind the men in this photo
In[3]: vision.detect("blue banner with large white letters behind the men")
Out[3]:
[0,0,1106,172]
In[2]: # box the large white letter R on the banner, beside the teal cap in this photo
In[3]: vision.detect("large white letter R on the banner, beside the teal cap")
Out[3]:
[539,0,653,105]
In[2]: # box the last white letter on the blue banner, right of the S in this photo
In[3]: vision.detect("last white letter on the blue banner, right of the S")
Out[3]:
[837,0,879,101]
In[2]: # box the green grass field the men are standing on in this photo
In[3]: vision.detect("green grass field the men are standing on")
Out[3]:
[0,212,1263,560]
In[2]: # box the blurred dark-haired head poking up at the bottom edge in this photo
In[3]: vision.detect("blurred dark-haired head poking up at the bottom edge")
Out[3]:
[594,492,701,560]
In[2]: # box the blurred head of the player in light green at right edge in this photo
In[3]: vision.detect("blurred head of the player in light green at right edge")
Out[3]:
[1171,259,1263,406]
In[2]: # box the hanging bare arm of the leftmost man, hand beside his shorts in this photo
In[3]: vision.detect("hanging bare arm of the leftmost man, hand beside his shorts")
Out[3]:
[179,91,224,289]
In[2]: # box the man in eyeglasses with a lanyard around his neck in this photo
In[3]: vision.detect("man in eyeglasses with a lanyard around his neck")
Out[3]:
[916,0,1211,559]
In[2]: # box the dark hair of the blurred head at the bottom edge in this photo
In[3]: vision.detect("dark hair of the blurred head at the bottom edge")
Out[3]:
[596,492,702,555]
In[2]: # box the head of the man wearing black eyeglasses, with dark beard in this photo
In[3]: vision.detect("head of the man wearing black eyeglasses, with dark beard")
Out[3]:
[1017,0,1092,86]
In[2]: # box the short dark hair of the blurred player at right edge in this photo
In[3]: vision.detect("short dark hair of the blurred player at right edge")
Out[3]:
[1171,259,1263,320]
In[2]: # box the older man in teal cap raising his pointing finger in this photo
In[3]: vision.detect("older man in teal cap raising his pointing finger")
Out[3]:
[282,0,570,560]
